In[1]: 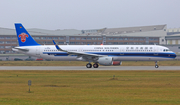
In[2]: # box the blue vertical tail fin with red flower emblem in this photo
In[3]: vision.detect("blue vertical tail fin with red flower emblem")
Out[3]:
[15,23,40,46]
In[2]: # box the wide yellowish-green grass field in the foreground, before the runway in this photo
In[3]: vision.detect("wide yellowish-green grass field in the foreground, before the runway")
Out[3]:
[0,71,180,105]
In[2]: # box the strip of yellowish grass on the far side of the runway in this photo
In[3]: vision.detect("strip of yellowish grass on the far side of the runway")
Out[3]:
[0,60,180,66]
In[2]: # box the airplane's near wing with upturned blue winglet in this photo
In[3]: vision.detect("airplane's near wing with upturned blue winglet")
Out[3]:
[53,40,106,57]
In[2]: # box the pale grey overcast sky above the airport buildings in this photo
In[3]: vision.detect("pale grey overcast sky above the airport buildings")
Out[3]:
[0,0,180,30]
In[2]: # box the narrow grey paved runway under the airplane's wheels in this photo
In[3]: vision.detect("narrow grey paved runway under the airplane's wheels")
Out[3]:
[0,66,180,70]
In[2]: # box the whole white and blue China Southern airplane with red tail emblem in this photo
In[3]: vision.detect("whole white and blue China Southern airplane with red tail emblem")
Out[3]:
[12,23,176,68]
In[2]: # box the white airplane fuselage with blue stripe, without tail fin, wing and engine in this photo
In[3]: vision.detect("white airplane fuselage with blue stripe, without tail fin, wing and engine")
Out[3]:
[13,45,176,61]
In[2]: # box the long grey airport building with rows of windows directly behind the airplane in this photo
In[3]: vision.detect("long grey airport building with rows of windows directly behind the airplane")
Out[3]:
[0,25,167,54]
